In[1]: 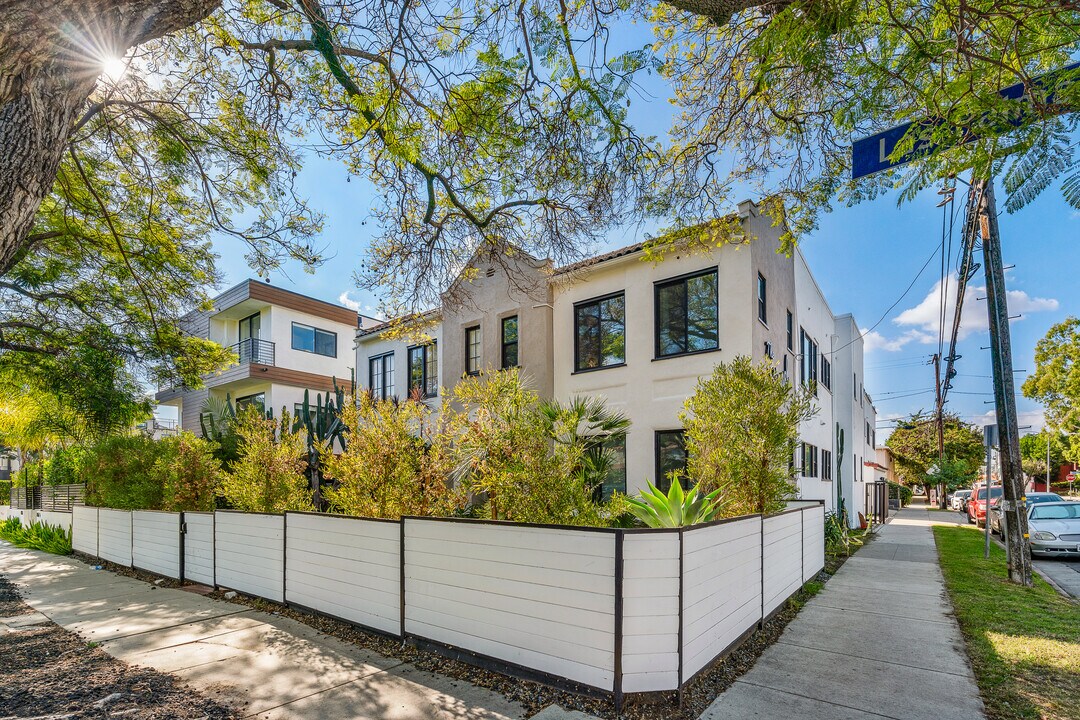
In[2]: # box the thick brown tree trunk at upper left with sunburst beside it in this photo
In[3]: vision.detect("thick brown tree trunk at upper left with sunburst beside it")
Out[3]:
[0,0,221,275]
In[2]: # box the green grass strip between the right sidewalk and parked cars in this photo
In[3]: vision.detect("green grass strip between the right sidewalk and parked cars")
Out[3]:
[934,526,1080,720]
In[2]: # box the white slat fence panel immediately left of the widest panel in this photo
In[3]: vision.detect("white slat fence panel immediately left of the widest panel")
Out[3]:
[285,513,401,635]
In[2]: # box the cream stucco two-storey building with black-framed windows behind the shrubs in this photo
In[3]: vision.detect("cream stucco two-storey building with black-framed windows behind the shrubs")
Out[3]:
[355,201,875,522]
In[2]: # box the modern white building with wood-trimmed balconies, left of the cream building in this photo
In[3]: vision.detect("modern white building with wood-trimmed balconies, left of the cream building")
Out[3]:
[157,280,376,435]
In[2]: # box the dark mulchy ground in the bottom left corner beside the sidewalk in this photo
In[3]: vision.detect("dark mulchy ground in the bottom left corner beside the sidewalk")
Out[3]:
[0,576,241,720]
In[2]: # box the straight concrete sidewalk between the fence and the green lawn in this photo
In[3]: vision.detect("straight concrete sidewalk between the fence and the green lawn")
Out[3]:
[702,508,985,720]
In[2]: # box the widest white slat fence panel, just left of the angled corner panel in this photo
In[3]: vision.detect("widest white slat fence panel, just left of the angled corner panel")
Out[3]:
[404,518,616,690]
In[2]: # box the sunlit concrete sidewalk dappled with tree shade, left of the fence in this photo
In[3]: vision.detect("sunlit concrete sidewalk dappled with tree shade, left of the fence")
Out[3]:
[0,542,531,720]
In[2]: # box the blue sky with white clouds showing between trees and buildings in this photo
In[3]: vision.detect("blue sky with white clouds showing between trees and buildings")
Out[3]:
[206,31,1080,441]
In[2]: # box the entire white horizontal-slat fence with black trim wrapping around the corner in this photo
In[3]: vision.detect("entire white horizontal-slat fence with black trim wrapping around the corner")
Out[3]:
[65,502,825,702]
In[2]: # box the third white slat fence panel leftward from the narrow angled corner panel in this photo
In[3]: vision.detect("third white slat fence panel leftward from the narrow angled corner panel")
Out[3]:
[214,511,285,602]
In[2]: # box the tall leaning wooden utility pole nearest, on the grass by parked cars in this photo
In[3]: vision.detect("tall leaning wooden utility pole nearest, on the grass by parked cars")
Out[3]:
[972,180,1031,587]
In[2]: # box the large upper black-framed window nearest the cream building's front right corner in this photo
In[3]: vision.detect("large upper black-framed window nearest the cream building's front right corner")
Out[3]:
[656,268,719,357]
